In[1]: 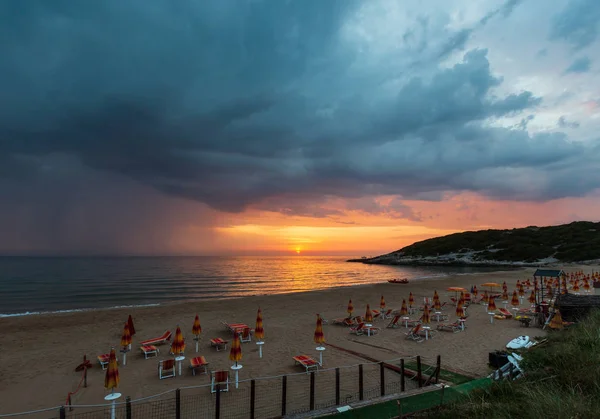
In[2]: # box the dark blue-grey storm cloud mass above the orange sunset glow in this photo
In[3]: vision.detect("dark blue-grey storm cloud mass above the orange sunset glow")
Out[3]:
[0,0,600,226]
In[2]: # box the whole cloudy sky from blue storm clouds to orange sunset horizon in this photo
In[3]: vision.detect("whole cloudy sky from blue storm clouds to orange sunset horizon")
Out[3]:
[0,0,600,255]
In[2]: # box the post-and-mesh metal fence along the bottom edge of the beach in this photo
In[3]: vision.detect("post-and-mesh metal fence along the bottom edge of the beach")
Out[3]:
[0,356,440,419]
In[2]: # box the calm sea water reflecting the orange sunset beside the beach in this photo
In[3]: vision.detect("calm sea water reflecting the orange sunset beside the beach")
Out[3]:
[0,256,502,317]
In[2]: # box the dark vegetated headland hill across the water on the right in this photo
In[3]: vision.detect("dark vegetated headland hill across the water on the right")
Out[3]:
[384,221,600,262]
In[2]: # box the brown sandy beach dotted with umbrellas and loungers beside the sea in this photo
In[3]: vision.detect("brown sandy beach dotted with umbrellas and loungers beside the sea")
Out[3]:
[0,266,597,413]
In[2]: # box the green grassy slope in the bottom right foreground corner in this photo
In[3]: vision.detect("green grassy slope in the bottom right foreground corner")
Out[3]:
[421,311,600,419]
